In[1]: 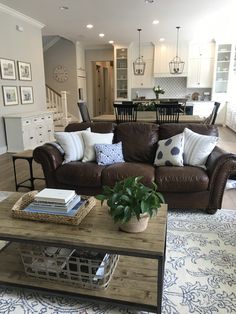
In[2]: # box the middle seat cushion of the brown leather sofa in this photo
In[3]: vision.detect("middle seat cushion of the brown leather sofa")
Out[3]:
[102,162,155,186]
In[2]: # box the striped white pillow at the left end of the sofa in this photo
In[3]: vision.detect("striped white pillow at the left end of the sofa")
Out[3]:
[54,128,91,164]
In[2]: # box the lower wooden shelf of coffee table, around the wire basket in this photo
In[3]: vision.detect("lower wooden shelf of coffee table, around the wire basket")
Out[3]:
[0,243,157,310]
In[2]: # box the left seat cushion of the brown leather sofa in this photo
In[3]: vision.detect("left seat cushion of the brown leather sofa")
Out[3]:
[56,161,104,187]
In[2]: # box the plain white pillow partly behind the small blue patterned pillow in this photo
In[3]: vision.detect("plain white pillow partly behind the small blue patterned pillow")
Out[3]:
[82,132,113,162]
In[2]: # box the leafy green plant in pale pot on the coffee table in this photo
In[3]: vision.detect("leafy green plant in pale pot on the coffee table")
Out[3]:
[96,177,164,232]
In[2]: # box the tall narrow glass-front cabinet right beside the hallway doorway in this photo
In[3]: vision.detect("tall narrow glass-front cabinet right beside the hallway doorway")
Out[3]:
[115,48,128,99]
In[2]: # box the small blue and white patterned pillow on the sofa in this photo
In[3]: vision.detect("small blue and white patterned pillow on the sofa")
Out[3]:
[94,142,125,166]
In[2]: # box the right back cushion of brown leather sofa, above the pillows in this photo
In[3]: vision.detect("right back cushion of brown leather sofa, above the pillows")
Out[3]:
[159,123,219,140]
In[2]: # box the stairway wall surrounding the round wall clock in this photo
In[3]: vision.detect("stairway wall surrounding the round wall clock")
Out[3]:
[44,38,78,116]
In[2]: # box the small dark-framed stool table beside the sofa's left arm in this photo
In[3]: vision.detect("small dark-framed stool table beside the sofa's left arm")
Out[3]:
[12,150,45,191]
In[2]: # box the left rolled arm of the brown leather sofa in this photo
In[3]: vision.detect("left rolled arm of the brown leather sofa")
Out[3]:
[33,144,64,188]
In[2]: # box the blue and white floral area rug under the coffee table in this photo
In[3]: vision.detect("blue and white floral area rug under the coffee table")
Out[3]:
[0,196,236,314]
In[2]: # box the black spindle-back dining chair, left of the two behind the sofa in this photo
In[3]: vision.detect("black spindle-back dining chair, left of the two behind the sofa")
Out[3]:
[113,101,138,124]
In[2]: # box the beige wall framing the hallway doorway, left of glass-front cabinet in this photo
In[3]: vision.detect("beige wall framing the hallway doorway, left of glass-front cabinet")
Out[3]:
[85,47,114,116]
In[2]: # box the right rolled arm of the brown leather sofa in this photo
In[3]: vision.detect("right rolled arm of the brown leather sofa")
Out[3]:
[206,146,236,209]
